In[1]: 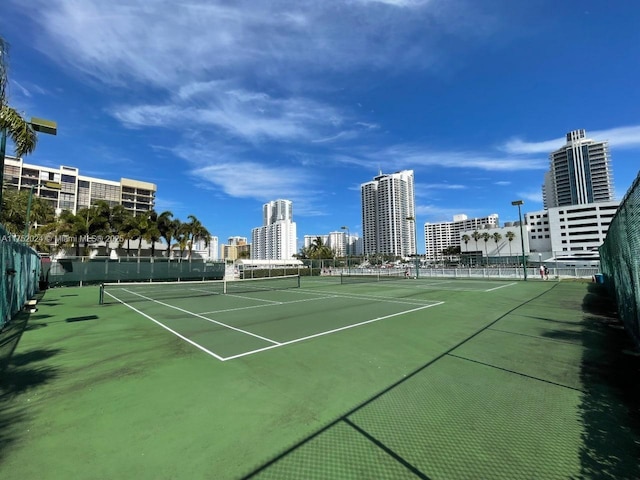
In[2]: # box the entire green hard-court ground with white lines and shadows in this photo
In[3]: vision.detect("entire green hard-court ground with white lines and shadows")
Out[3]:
[0,277,640,480]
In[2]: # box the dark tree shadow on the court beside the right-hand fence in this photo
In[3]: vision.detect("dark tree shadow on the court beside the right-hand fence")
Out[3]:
[579,288,640,480]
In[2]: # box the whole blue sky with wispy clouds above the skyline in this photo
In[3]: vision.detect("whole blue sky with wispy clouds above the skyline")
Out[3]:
[0,0,640,252]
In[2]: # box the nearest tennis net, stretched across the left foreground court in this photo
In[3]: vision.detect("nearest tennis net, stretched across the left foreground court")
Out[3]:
[100,275,300,305]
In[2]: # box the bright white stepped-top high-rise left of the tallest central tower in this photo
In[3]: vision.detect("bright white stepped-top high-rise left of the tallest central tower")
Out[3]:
[251,200,297,260]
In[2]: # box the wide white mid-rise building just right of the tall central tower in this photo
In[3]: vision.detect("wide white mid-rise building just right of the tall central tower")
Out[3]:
[424,213,499,261]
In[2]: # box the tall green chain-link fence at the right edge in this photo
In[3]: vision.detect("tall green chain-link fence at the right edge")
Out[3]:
[600,174,640,346]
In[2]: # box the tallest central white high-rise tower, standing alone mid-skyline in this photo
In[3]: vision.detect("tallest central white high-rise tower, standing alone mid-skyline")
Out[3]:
[360,170,417,257]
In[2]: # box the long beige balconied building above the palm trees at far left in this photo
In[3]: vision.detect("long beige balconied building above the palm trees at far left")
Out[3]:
[3,157,157,214]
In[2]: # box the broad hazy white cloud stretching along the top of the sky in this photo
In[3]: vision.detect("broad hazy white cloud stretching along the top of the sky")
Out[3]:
[17,0,495,88]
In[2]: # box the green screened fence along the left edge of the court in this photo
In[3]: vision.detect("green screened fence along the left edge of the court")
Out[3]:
[0,225,40,329]
